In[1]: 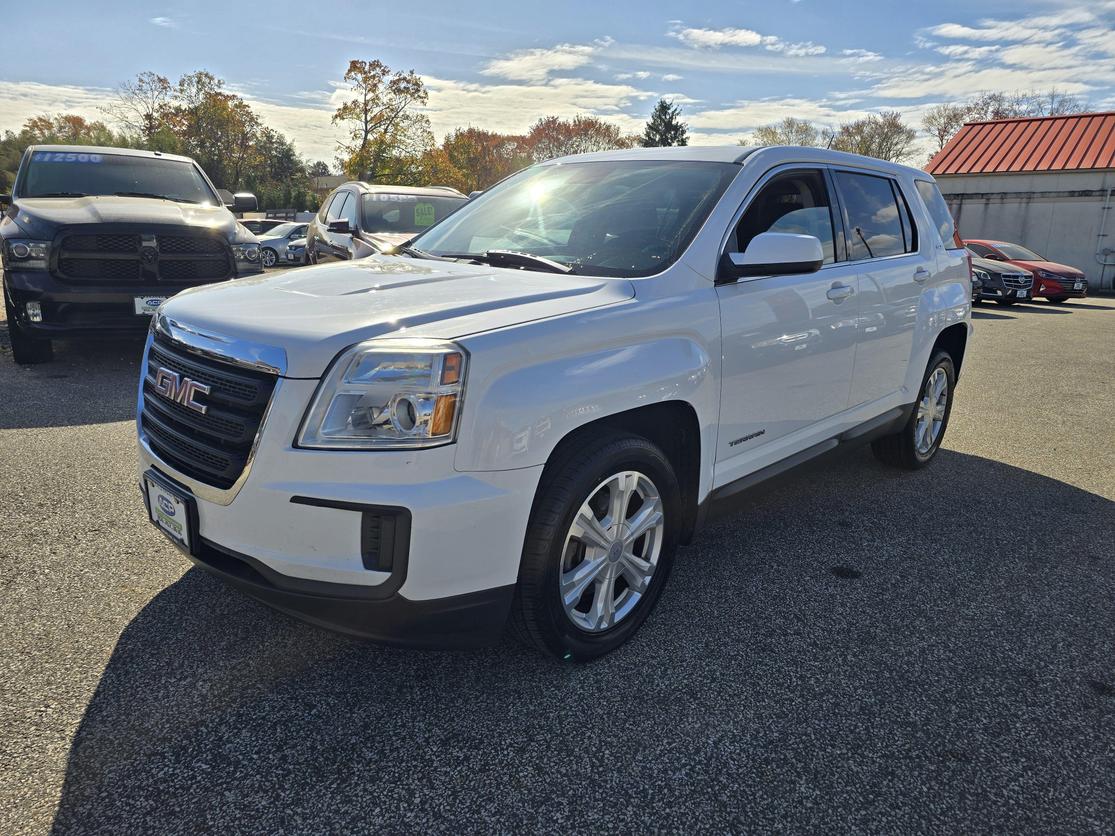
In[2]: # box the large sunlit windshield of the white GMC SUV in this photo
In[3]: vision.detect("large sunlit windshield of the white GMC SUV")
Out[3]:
[414,159,739,278]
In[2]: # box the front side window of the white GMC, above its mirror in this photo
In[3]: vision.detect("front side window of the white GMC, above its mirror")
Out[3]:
[736,169,836,264]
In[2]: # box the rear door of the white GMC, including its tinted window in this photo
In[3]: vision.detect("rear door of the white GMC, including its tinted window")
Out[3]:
[833,168,935,407]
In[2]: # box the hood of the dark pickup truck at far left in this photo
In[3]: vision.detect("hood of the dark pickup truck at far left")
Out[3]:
[16,196,236,241]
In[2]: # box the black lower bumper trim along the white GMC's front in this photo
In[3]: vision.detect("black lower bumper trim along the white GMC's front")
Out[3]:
[190,539,515,648]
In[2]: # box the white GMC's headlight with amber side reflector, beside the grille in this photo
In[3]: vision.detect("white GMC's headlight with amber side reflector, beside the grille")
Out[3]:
[298,339,467,449]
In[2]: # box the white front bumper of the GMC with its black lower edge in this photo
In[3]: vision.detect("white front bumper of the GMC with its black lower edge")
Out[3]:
[138,378,542,644]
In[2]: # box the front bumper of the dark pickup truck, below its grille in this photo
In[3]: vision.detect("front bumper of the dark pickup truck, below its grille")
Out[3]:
[3,270,236,339]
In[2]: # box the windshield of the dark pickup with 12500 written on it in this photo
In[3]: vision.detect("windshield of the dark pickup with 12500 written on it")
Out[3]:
[18,150,220,205]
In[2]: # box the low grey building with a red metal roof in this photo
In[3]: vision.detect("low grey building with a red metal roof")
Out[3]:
[925,113,1115,290]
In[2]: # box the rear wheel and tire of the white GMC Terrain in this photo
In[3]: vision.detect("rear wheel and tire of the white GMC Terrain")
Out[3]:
[871,351,957,470]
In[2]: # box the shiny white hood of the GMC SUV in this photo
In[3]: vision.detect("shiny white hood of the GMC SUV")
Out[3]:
[162,255,634,378]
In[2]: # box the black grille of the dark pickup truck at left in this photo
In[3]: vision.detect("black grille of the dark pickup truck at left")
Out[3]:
[54,226,233,286]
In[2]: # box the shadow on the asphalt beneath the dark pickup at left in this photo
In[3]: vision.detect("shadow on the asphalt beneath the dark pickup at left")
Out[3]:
[0,320,144,429]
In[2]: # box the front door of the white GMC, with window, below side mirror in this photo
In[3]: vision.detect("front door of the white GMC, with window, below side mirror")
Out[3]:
[716,168,859,484]
